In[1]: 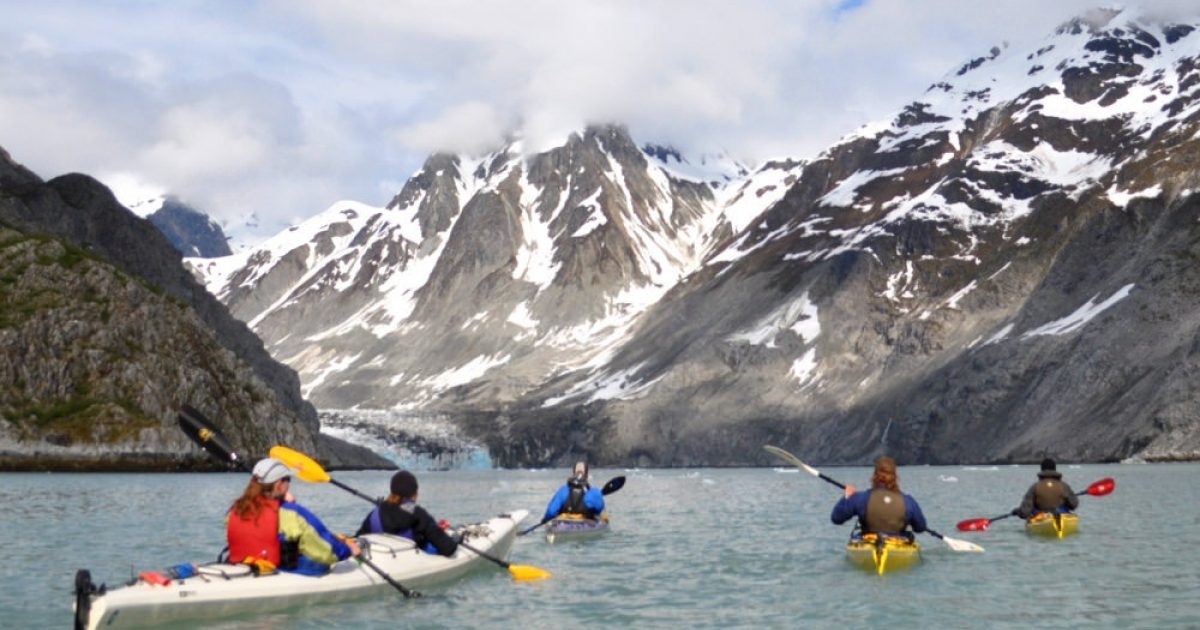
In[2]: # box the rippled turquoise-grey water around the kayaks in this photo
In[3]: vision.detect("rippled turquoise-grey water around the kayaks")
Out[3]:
[0,464,1200,629]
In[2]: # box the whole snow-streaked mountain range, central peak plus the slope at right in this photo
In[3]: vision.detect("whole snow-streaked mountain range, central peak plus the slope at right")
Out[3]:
[194,11,1200,466]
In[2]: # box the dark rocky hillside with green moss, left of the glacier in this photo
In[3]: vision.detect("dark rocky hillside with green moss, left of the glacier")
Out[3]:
[0,151,385,469]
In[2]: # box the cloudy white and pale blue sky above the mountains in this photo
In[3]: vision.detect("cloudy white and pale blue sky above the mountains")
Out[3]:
[0,0,1188,240]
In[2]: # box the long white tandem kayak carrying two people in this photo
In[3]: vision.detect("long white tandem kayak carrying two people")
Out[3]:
[76,510,528,630]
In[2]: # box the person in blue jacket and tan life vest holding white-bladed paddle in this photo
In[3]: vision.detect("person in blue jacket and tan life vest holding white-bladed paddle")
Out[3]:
[830,455,925,539]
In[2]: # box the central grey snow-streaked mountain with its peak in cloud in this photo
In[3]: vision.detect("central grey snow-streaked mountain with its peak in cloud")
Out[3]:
[192,126,768,408]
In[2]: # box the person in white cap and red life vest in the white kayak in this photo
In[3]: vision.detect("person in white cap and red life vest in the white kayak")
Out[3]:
[226,457,360,575]
